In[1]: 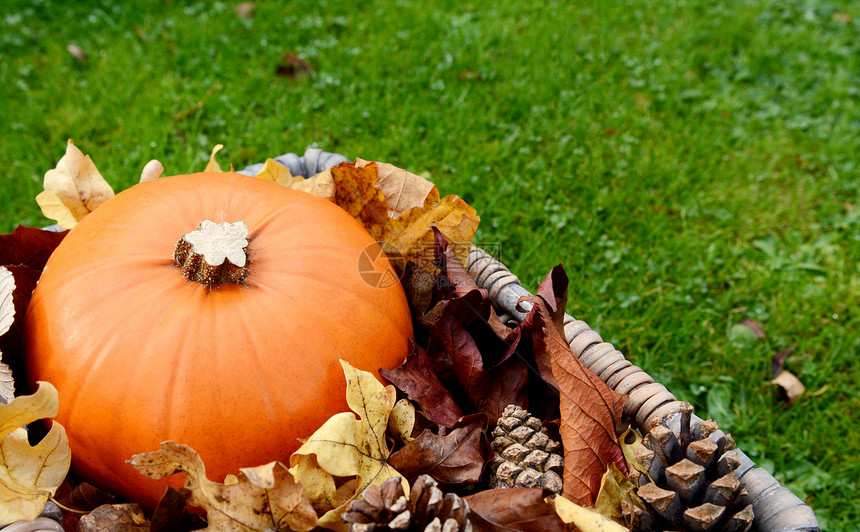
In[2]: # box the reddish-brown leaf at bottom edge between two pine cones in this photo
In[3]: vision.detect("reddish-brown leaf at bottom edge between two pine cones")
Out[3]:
[464,488,567,532]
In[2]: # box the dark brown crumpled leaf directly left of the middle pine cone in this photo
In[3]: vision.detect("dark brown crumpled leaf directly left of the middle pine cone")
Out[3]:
[388,414,493,484]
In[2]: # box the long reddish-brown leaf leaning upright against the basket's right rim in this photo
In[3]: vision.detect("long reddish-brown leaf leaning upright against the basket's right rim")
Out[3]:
[523,266,627,506]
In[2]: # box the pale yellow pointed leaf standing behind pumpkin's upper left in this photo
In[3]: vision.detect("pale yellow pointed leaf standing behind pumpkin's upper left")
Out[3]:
[36,139,114,229]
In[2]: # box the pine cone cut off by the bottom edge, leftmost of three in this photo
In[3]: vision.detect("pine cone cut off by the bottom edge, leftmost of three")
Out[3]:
[343,475,472,532]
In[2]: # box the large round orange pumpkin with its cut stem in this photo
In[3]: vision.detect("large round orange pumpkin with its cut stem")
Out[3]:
[24,173,412,509]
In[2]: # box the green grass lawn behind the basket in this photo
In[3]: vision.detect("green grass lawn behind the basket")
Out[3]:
[0,0,860,530]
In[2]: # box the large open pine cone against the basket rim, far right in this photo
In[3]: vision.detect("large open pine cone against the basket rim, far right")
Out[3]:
[622,403,753,532]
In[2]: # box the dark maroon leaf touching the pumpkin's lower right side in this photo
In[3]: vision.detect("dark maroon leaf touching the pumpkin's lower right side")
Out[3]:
[379,341,463,428]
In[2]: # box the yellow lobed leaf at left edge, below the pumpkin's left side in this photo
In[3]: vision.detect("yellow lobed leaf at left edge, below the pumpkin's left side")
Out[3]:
[0,382,72,526]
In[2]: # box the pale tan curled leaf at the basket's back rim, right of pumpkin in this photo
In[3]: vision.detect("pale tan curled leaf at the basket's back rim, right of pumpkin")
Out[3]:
[355,157,439,218]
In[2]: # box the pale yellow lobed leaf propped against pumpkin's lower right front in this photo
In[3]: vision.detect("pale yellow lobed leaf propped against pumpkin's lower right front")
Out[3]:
[290,360,409,530]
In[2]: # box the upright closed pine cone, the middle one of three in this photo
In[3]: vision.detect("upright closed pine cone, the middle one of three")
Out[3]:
[490,405,564,493]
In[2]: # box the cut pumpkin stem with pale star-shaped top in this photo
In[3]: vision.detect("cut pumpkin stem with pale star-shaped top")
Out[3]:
[173,220,248,286]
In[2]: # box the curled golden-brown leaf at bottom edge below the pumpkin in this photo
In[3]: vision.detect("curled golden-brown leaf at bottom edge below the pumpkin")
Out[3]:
[128,441,316,532]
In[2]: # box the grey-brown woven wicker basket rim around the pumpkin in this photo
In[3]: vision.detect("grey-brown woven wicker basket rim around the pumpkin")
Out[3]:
[247,148,821,532]
